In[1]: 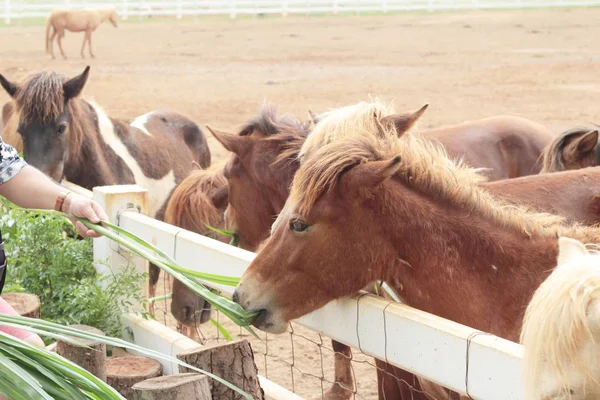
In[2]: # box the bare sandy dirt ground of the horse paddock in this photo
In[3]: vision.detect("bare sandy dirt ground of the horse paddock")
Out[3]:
[0,9,600,399]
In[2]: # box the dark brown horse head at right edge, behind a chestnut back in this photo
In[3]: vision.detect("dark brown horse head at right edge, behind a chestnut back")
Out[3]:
[541,126,600,173]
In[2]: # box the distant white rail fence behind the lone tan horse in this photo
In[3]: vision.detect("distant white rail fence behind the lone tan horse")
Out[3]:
[0,0,600,24]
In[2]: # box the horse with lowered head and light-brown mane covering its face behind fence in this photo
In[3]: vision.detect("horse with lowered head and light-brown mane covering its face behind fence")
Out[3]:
[165,165,229,340]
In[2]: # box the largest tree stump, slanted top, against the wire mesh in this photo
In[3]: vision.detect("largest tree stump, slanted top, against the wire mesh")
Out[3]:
[177,339,265,400]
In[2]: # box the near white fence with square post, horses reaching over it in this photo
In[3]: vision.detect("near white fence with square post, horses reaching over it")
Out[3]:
[78,185,525,400]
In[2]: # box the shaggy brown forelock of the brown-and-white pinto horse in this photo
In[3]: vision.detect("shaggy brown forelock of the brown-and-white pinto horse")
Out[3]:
[15,72,66,124]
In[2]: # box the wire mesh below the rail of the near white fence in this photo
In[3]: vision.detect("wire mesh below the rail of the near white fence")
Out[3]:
[149,274,458,400]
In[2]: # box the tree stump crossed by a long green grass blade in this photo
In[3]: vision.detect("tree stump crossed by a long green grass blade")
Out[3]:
[56,325,106,382]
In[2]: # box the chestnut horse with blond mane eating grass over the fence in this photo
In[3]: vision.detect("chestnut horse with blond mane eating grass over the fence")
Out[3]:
[234,100,598,400]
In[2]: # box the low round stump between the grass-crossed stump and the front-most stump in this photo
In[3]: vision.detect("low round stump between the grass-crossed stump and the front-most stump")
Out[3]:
[106,356,162,400]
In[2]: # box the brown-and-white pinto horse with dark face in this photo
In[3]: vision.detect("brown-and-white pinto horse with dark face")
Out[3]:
[0,67,210,304]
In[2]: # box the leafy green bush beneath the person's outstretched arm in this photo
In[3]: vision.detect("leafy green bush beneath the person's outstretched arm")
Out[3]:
[0,199,145,336]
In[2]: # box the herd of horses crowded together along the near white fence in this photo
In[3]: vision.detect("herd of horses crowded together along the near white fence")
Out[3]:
[0,67,600,400]
